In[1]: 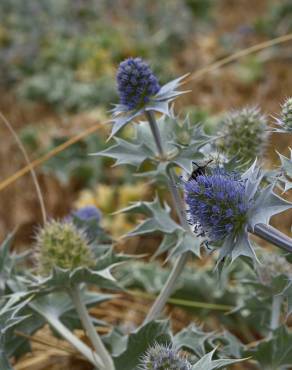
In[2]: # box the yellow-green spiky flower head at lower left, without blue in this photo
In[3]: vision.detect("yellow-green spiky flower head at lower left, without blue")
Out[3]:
[36,220,94,275]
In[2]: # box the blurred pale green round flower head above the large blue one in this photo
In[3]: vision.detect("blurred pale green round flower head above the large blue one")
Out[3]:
[220,107,268,162]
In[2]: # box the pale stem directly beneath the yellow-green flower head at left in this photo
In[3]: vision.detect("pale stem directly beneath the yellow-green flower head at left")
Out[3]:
[70,285,115,370]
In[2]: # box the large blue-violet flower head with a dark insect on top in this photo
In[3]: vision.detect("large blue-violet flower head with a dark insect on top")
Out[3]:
[184,168,249,242]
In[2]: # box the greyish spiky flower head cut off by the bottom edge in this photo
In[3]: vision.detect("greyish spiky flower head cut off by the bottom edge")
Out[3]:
[140,344,191,370]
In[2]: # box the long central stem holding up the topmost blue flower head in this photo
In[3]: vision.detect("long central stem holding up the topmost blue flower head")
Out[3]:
[144,111,190,324]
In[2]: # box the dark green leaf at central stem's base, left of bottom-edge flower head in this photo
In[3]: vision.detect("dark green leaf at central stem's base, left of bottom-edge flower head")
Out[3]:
[113,320,171,370]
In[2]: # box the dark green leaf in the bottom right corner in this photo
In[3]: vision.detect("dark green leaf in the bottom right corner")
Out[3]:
[244,326,292,370]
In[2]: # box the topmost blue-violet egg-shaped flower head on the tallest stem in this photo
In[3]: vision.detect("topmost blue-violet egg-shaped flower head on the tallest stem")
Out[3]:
[117,58,160,110]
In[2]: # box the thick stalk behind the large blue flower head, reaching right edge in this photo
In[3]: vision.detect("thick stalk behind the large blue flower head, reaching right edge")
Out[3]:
[249,223,292,253]
